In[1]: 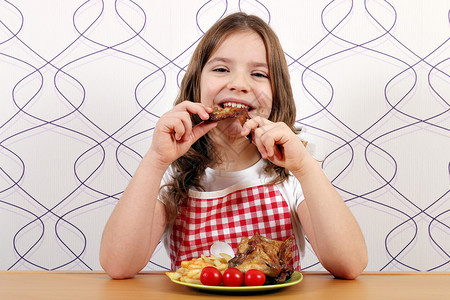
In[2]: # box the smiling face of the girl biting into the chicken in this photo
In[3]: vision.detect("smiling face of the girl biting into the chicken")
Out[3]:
[200,31,272,132]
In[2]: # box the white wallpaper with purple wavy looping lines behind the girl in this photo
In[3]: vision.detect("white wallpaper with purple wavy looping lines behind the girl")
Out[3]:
[0,0,450,271]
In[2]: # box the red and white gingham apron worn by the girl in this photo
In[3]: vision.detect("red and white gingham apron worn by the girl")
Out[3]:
[170,185,300,271]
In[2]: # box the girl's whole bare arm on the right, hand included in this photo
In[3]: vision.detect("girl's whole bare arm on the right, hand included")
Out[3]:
[242,117,367,279]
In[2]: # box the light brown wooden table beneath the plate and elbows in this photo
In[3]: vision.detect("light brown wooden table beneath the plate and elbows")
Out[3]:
[0,271,450,300]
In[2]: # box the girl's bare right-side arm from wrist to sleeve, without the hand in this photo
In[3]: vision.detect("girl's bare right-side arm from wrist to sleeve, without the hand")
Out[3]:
[294,154,367,279]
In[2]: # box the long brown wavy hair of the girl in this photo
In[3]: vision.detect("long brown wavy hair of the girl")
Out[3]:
[161,12,296,222]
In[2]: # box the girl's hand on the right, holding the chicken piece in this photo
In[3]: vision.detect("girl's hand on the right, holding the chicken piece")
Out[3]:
[241,117,307,173]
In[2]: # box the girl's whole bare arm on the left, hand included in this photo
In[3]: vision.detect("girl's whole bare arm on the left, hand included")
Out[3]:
[100,101,216,279]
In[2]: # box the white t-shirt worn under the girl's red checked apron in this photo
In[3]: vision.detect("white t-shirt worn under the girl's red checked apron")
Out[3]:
[158,159,305,257]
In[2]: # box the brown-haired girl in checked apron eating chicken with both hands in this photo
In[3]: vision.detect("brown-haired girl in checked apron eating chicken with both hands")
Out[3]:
[100,13,367,279]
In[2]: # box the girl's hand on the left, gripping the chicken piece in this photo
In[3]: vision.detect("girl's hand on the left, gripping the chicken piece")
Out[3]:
[149,101,217,168]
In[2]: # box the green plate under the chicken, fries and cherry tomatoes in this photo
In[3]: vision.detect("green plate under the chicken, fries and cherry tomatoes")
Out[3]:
[171,271,303,292]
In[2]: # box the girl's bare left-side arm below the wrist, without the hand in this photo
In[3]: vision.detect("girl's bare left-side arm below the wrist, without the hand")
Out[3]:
[100,155,167,279]
